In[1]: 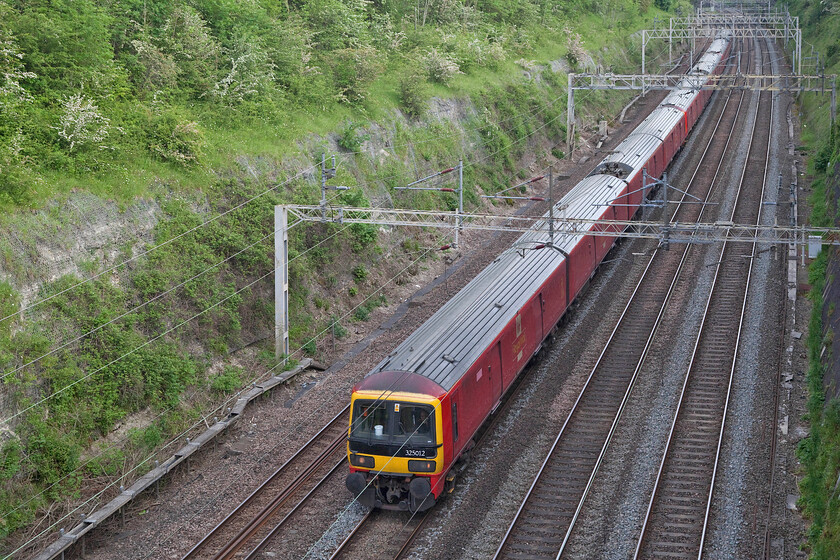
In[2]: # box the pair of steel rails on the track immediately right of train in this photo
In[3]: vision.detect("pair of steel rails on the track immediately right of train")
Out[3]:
[494,38,743,558]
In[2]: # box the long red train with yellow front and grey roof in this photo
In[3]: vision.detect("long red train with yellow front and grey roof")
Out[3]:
[346,39,730,511]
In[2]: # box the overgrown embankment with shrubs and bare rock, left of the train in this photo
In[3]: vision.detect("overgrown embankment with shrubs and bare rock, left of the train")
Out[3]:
[0,0,671,552]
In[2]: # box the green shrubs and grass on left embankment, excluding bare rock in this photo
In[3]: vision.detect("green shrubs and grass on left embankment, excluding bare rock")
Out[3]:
[0,0,676,536]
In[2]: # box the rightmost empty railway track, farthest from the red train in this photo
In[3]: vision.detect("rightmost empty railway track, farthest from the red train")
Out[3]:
[635,37,774,559]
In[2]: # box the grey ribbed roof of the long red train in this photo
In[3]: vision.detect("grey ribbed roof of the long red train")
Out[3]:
[358,36,726,392]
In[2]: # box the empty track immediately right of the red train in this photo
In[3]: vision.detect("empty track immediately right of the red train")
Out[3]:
[495,39,756,558]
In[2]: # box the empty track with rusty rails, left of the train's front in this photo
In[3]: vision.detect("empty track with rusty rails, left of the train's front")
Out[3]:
[182,405,350,560]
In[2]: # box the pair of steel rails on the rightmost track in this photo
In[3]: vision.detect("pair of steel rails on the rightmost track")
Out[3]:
[634,36,772,559]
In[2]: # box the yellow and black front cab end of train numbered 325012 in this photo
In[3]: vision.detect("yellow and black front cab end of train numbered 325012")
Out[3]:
[346,391,446,511]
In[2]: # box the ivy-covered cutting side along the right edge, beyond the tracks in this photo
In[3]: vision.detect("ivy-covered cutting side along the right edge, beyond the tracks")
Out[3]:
[791,0,840,560]
